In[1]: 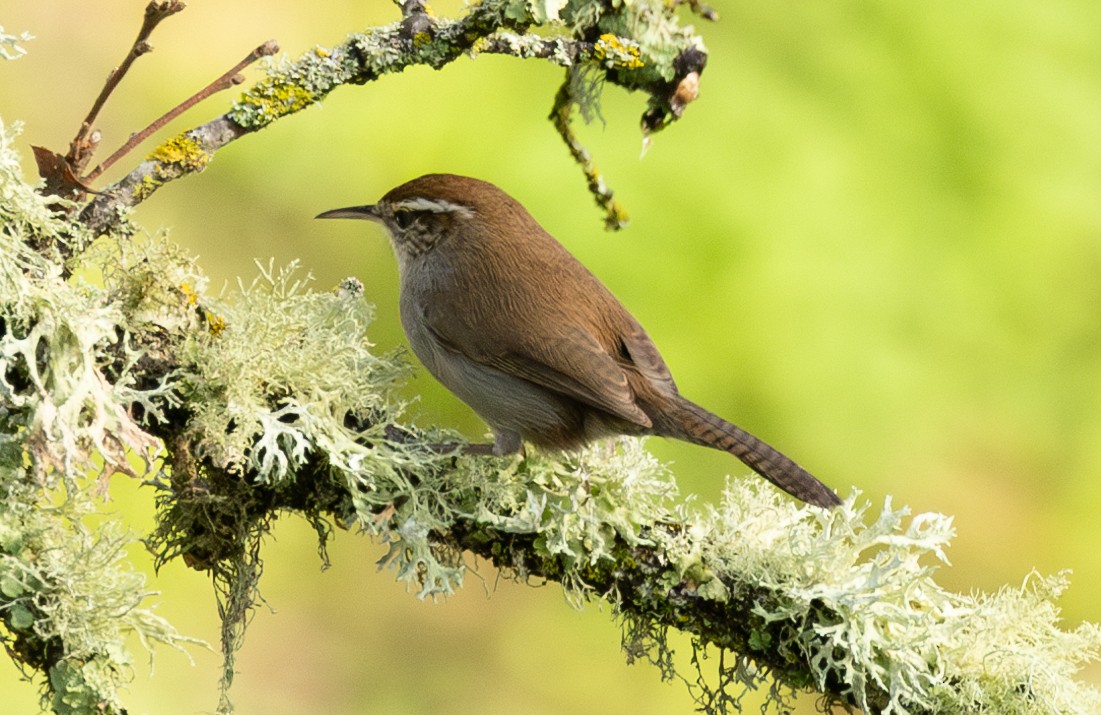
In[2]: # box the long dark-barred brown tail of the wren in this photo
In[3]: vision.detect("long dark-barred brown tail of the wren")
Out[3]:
[655,396,841,508]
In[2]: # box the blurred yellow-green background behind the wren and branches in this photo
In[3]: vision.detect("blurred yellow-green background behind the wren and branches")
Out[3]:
[0,0,1101,715]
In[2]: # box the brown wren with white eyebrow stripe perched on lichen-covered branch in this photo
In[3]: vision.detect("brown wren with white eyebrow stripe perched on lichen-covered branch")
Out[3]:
[318,174,840,507]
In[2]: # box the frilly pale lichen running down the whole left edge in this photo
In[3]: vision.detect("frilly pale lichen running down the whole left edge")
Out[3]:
[0,115,202,713]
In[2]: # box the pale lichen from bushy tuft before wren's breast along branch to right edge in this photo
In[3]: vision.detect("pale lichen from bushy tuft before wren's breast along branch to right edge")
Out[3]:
[144,243,1101,715]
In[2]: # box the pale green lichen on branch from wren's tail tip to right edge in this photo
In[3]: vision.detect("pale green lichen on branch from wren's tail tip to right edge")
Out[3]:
[647,481,1101,715]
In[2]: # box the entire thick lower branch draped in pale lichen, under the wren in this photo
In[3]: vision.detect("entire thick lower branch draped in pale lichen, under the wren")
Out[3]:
[0,111,1101,715]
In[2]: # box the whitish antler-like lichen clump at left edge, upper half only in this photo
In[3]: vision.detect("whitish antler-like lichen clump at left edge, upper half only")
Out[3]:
[0,124,159,486]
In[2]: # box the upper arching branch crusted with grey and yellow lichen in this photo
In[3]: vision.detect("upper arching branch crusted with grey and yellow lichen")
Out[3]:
[83,0,707,236]
